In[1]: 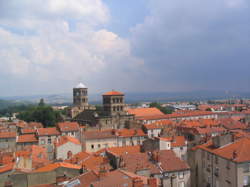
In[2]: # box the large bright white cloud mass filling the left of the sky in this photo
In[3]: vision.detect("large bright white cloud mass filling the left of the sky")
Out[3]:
[0,0,143,95]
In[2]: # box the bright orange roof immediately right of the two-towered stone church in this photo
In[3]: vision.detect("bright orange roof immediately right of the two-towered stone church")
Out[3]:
[127,107,164,117]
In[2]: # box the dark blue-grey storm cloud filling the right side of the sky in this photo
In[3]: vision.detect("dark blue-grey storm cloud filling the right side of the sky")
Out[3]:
[132,0,250,90]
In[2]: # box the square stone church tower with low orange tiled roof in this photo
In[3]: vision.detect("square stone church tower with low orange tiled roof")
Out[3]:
[102,91,124,116]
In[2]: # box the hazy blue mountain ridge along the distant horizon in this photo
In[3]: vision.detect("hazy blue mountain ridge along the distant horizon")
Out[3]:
[0,91,250,105]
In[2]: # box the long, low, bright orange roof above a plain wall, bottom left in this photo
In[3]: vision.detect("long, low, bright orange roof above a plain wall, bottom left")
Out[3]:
[34,162,81,172]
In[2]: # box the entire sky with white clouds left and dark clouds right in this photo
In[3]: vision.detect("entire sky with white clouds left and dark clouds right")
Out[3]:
[0,0,250,96]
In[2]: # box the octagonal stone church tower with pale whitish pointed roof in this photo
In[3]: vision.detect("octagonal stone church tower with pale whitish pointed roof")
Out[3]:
[73,83,88,107]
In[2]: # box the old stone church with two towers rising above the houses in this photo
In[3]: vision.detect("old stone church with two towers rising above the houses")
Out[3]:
[70,83,134,129]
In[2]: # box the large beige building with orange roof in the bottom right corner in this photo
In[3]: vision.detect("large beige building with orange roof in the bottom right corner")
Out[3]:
[189,134,250,187]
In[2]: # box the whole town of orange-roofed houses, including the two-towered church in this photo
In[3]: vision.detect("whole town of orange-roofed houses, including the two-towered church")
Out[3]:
[0,83,250,187]
